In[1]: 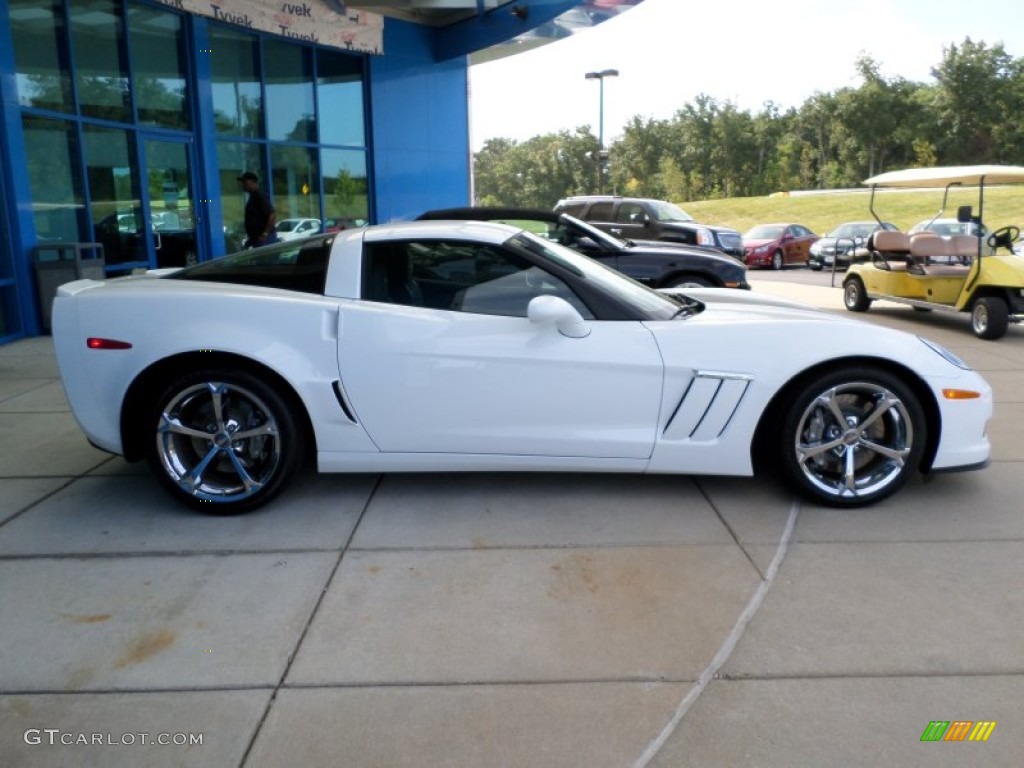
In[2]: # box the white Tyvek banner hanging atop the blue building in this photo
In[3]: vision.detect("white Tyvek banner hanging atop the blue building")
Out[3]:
[158,0,384,54]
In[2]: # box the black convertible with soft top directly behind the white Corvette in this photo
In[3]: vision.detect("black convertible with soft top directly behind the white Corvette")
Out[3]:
[419,207,750,288]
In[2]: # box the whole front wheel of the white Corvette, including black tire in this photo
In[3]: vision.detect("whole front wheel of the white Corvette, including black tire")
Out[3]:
[777,367,928,507]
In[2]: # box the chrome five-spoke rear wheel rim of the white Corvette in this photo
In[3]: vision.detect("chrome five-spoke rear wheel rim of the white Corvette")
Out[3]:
[156,381,282,502]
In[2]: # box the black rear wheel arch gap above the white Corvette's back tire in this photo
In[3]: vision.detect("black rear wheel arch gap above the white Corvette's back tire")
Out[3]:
[121,351,316,462]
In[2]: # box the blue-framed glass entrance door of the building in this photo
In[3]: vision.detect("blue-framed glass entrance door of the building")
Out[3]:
[142,136,200,267]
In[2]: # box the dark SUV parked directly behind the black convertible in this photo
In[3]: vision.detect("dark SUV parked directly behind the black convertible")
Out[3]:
[555,195,743,259]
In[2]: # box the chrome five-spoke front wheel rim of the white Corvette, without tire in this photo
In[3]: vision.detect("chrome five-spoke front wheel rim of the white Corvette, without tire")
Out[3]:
[793,382,914,501]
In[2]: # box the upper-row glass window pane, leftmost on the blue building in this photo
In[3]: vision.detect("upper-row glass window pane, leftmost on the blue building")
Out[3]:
[8,0,72,112]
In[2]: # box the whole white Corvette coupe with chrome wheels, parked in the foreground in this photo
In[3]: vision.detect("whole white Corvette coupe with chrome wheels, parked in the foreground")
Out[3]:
[52,221,992,512]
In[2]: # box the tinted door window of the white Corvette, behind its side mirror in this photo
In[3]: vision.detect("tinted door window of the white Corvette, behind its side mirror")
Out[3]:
[362,240,593,319]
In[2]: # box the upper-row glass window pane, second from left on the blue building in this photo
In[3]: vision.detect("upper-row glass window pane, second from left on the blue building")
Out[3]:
[69,0,131,122]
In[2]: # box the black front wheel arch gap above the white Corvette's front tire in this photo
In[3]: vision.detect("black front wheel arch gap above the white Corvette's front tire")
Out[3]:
[751,356,942,473]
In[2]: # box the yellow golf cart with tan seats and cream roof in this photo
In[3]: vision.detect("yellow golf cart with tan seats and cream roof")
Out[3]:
[843,165,1024,339]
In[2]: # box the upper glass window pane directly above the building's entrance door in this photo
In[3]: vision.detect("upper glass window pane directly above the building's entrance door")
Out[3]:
[128,4,191,130]
